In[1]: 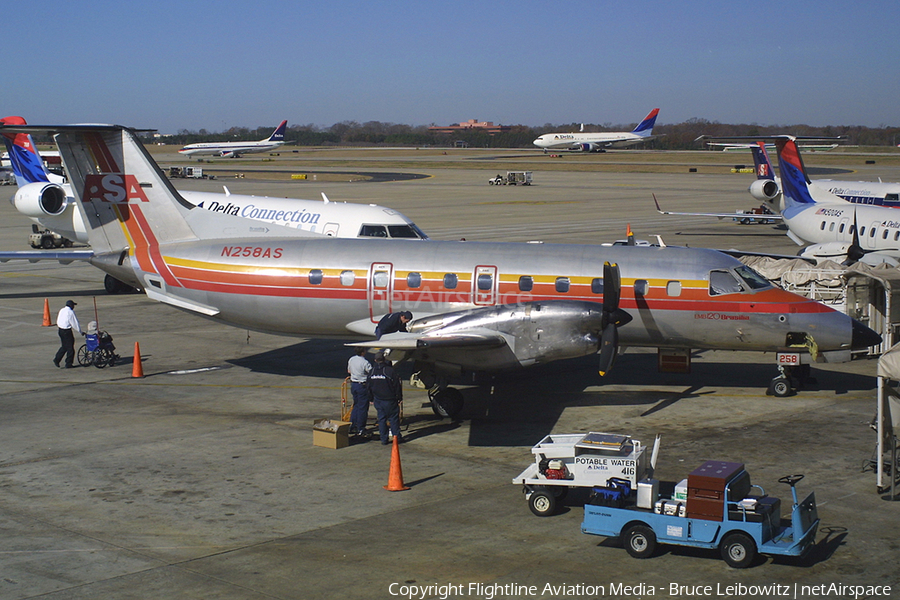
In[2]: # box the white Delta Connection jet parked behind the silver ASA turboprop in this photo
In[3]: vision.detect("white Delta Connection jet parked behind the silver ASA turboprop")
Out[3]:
[0,117,428,294]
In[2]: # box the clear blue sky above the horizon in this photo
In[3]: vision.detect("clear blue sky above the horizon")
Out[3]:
[7,0,900,133]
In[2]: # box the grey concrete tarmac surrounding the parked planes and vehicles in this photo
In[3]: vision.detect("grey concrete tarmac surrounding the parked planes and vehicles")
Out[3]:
[0,149,900,600]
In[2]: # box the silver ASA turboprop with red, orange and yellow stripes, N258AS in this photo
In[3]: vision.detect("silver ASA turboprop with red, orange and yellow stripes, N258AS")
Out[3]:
[0,120,880,414]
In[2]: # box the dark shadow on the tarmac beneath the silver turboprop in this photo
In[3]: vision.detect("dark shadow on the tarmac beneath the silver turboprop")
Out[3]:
[228,340,875,446]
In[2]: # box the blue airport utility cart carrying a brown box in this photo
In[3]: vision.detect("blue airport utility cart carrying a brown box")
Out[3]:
[581,461,819,569]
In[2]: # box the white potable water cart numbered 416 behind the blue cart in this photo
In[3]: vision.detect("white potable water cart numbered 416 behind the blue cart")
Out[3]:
[513,432,659,517]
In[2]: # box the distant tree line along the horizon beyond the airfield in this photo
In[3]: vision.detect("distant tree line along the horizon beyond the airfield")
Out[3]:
[155,119,900,150]
